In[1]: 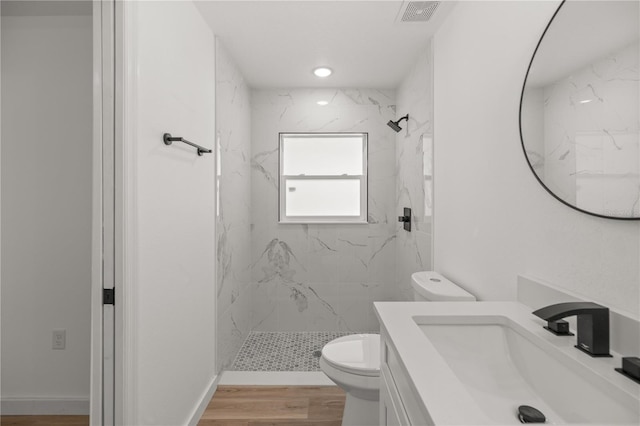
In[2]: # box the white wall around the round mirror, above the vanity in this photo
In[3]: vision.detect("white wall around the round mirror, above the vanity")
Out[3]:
[434,1,640,315]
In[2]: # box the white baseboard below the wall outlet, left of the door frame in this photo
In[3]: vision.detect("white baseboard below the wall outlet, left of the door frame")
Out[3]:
[0,397,89,416]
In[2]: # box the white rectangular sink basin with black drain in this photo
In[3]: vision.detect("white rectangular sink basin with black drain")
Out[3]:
[419,318,639,425]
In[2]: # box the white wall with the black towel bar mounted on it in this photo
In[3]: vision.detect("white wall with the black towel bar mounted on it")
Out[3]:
[125,1,216,425]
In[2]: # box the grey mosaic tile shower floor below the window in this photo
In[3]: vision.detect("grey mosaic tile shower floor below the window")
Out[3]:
[229,331,354,371]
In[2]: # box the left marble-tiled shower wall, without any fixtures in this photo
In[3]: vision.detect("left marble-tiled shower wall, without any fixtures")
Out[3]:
[216,41,251,371]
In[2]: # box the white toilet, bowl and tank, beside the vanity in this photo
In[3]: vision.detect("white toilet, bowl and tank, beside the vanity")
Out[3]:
[320,271,476,426]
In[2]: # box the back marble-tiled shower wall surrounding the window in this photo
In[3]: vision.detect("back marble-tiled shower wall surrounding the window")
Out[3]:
[250,89,396,331]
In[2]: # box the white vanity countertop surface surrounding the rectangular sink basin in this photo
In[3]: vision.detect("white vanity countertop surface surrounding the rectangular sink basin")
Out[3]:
[374,302,640,425]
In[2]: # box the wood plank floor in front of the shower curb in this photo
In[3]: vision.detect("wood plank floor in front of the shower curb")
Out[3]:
[198,386,345,426]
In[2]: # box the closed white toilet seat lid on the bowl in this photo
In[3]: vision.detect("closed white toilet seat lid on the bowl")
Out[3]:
[322,334,380,376]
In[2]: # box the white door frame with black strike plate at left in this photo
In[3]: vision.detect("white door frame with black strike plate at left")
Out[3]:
[90,0,132,426]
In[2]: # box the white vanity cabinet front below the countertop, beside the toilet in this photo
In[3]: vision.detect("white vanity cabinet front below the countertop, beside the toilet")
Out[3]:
[380,330,433,426]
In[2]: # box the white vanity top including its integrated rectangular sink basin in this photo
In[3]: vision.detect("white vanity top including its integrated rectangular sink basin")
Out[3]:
[375,302,640,426]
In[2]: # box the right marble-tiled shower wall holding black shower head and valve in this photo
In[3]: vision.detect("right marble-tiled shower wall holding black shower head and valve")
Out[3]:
[394,44,433,300]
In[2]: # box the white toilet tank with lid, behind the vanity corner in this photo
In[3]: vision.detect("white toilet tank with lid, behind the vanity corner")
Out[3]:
[411,271,476,302]
